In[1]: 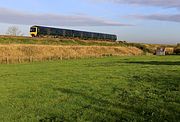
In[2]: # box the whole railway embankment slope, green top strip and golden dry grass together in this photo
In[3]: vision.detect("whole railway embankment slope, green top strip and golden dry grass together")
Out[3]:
[0,36,144,63]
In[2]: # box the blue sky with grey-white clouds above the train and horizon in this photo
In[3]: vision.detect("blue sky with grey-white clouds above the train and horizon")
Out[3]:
[0,0,180,44]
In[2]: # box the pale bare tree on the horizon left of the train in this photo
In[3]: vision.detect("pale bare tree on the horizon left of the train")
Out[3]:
[6,26,23,36]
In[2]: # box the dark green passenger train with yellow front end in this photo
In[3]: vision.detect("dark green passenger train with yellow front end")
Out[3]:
[30,26,117,41]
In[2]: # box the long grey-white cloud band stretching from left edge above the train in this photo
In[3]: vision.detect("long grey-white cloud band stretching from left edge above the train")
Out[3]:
[0,8,131,26]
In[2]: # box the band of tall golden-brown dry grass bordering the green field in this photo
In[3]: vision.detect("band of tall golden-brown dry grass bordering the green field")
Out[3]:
[0,44,143,63]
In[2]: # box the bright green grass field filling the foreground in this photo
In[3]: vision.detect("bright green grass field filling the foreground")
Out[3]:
[0,56,180,122]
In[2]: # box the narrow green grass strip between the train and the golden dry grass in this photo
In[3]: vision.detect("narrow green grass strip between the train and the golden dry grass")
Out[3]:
[0,36,127,46]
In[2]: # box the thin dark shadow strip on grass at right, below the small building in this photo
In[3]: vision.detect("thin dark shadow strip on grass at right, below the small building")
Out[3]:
[125,61,180,65]
